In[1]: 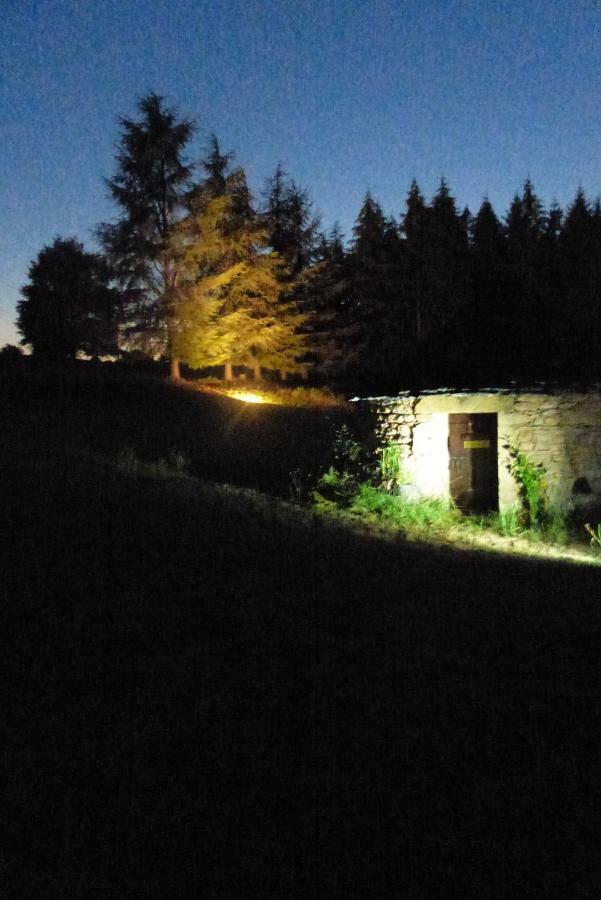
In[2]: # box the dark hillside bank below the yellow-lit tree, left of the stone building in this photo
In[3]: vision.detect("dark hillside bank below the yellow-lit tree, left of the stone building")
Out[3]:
[0,359,353,497]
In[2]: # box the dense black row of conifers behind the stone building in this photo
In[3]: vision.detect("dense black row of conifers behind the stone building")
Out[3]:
[307,179,601,391]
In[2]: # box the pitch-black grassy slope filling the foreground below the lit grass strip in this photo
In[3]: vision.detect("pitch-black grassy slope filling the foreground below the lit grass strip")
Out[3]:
[0,364,601,900]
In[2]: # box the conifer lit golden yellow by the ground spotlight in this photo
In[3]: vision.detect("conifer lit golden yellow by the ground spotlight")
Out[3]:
[171,193,306,380]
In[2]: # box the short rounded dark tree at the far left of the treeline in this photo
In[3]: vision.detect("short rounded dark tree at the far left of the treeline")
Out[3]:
[17,237,119,359]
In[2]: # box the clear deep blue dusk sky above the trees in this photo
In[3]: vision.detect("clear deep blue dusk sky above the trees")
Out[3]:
[0,0,601,345]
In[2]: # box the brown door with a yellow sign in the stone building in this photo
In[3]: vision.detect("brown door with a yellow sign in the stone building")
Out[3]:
[449,413,499,513]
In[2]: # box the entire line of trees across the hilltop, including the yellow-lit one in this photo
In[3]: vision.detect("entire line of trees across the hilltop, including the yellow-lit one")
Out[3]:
[17,93,601,393]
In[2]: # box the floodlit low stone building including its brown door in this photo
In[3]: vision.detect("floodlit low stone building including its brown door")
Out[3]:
[358,389,601,515]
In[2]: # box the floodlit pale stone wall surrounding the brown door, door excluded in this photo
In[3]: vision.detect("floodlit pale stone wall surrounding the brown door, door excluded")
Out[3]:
[360,391,601,514]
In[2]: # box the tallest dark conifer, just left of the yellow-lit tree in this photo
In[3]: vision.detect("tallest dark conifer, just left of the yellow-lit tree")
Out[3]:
[99,92,194,375]
